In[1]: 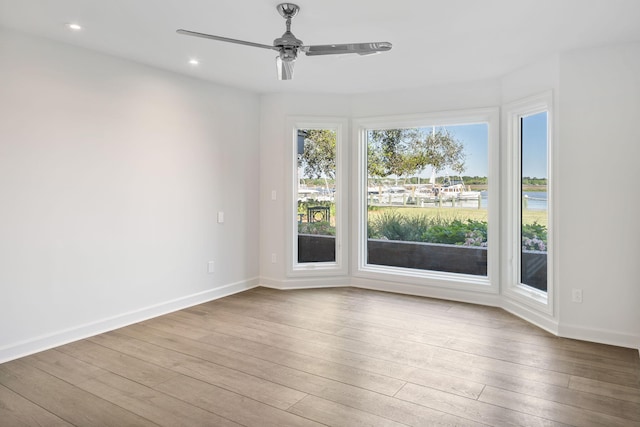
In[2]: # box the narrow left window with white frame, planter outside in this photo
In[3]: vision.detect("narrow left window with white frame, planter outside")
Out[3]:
[288,119,346,275]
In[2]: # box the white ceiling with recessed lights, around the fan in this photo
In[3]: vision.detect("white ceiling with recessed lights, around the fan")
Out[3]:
[0,0,640,94]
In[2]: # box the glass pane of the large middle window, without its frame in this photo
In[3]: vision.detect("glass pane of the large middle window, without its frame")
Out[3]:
[366,123,491,277]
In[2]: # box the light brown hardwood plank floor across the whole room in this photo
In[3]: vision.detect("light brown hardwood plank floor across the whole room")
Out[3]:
[0,288,640,427]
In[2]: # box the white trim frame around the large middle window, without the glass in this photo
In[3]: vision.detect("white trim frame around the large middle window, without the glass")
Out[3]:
[351,108,500,294]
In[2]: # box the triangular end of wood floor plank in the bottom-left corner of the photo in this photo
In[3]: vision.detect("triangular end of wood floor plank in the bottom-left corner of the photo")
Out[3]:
[0,385,72,427]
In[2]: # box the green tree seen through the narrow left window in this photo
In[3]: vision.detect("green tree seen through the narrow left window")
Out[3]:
[298,129,336,179]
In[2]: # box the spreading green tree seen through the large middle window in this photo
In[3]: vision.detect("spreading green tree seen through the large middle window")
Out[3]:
[367,128,465,178]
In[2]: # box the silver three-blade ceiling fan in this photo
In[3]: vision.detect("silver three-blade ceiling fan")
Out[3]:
[176,3,392,80]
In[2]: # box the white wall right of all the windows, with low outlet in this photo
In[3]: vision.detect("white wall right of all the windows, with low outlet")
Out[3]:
[559,43,640,348]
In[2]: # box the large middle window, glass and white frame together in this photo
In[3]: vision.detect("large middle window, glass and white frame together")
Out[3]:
[356,109,498,292]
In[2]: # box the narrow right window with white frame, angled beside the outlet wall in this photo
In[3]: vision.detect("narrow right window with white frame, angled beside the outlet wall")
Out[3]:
[505,93,553,313]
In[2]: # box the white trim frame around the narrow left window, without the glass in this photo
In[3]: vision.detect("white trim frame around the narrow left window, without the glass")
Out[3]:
[285,117,349,277]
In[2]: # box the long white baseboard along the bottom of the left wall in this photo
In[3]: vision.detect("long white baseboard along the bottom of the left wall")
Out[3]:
[0,277,259,363]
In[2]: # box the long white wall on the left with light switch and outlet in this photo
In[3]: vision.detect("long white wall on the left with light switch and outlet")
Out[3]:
[0,31,260,362]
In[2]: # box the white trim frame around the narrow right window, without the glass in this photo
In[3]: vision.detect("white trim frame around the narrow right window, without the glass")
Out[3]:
[502,91,556,316]
